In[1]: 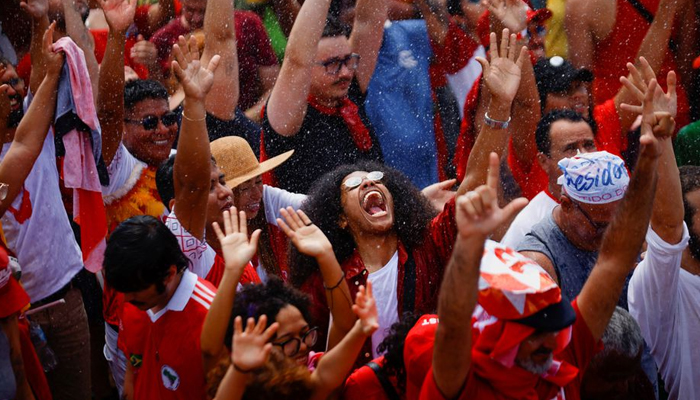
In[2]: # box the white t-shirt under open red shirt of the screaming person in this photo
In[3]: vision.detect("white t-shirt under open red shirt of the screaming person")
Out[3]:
[367,251,399,358]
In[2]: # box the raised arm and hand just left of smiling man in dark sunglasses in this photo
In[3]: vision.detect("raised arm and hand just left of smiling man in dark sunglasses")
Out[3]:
[97,0,136,165]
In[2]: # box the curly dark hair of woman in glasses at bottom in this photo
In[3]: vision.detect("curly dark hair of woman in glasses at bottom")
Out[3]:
[225,275,311,349]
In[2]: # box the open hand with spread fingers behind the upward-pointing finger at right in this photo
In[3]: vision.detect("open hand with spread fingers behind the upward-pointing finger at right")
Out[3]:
[620,57,678,118]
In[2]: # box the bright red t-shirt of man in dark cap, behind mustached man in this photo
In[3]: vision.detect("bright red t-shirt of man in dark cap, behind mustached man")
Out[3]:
[508,99,627,200]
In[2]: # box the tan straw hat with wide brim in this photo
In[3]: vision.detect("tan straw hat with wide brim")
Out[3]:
[210,136,294,189]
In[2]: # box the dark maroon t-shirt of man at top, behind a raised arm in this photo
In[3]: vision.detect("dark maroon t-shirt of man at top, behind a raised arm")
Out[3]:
[151,10,277,110]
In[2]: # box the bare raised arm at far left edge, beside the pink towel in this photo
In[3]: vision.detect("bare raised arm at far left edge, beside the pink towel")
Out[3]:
[0,22,63,216]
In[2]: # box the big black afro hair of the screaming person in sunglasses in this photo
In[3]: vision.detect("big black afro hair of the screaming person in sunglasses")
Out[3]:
[289,161,436,287]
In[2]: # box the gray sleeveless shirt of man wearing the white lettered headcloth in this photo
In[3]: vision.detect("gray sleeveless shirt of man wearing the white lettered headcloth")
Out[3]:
[518,213,631,309]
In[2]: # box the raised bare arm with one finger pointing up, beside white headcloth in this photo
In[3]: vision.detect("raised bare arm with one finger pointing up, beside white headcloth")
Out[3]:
[578,79,674,340]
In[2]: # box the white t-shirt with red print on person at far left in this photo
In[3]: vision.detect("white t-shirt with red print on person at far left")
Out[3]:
[0,95,83,302]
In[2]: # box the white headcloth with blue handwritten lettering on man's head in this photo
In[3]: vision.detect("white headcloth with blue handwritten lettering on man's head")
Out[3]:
[557,151,630,204]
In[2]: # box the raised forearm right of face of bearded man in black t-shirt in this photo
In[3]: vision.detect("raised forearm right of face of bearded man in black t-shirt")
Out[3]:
[350,0,388,93]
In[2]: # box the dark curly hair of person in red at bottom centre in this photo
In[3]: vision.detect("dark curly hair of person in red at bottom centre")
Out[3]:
[377,312,420,394]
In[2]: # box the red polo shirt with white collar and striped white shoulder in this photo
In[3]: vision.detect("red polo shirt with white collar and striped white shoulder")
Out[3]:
[119,271,216,400]
